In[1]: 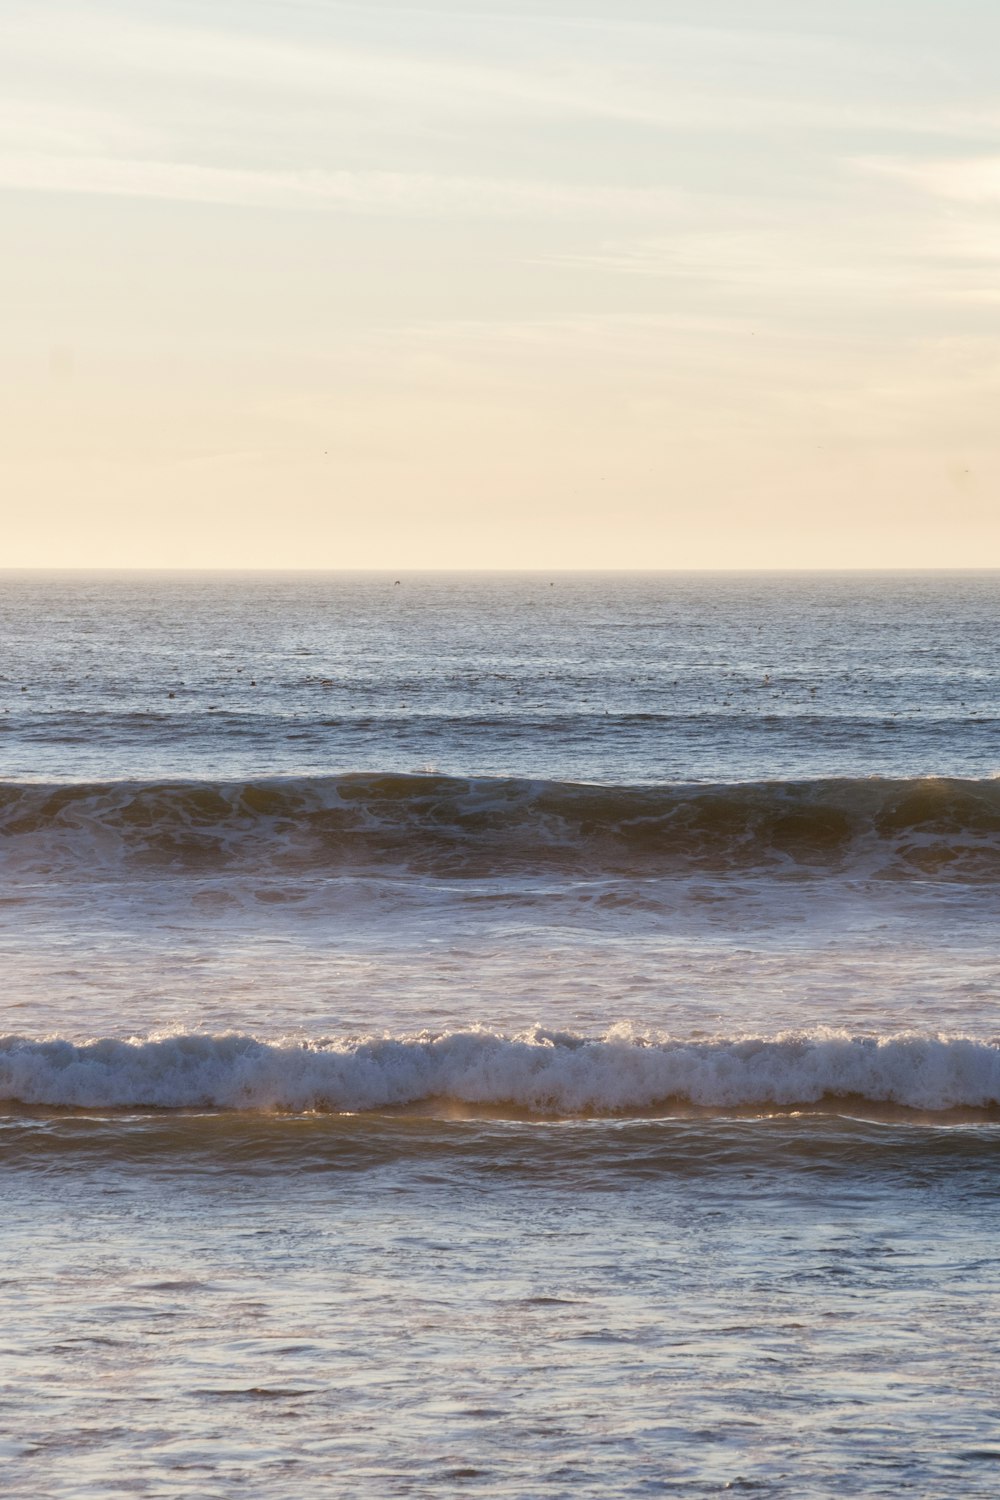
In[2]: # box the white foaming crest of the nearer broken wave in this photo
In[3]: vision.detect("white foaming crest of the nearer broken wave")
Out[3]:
[0,1028,1000,1116]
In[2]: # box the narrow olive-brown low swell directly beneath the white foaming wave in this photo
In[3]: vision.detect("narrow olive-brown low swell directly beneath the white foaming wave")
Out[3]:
[0,1110,1000,1176]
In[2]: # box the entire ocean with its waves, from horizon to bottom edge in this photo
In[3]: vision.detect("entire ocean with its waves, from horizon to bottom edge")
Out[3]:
[0,573,1000,1500]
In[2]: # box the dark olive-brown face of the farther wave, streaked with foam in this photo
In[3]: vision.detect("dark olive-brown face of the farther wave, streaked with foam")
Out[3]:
[0,774,1000,881]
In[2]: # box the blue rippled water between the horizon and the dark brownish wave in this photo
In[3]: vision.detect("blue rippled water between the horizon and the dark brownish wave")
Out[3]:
[0,573,1000,783]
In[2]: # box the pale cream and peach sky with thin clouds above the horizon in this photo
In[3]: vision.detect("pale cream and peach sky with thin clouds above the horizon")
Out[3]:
[0,0,1000,569]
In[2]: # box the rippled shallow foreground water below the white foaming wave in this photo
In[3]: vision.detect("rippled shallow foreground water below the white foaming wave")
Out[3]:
[3,1118,1000,1497]
